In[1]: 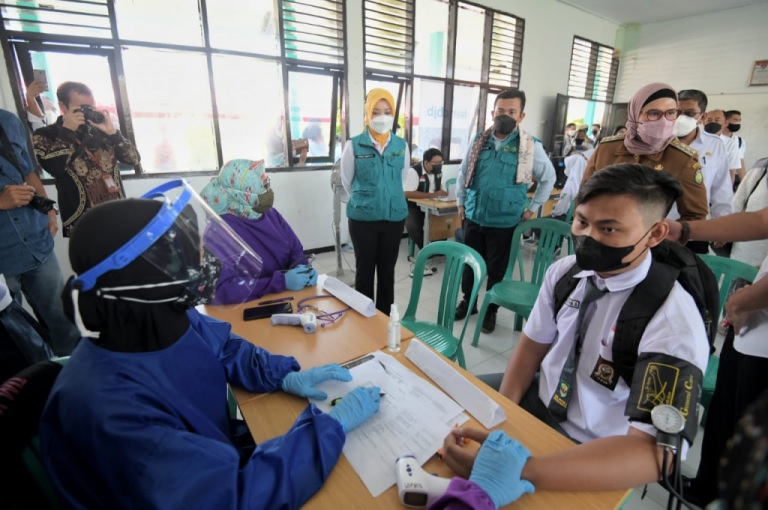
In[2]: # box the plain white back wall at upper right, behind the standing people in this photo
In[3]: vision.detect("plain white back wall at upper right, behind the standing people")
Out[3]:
[616,3,768,168]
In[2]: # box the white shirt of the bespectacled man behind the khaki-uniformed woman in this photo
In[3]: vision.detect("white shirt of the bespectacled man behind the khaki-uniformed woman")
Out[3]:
[690,127,733,218]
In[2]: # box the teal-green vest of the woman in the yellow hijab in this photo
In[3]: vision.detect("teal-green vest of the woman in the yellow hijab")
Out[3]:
[347,131,408,221]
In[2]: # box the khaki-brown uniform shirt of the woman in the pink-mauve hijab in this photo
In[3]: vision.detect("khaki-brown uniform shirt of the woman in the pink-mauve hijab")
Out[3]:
[581,135,709,221]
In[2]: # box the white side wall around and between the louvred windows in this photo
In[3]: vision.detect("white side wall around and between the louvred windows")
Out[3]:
[0,0,618,275]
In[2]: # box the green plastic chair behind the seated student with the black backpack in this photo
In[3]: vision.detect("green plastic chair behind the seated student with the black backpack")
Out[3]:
[699,254,757,422]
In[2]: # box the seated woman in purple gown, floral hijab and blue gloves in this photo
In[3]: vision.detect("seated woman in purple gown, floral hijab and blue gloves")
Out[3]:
[200,159,317,304]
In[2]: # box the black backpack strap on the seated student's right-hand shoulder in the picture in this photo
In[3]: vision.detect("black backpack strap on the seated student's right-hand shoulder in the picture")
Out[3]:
[613,260,680,386]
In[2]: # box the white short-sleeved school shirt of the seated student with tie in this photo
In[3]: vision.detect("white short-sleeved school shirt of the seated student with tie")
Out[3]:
[523,251,709,442]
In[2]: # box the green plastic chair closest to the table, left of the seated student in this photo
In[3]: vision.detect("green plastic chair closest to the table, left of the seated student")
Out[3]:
[400,241,486,368]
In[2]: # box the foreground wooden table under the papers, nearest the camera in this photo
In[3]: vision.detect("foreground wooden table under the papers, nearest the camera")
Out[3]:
[240,341,630,510]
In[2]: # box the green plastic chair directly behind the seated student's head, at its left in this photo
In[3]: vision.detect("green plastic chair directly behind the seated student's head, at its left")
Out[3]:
[470,218,573,347]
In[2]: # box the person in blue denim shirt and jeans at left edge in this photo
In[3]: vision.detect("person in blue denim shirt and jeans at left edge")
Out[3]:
[0,110,80,356]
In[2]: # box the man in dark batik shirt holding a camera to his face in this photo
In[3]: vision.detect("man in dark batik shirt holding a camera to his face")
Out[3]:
[33,81,139,237]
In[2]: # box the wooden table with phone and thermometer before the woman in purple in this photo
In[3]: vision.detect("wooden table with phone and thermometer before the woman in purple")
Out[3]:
[199,287,413,404]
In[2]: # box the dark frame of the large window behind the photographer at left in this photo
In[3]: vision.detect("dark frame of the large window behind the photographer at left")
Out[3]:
[0,0,349,179]
